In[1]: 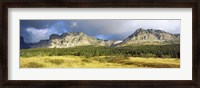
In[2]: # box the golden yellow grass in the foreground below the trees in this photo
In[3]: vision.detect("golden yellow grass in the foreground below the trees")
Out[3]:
[20,56,180,68]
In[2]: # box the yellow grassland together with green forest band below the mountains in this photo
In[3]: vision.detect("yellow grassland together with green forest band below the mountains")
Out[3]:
[20,45,180,68]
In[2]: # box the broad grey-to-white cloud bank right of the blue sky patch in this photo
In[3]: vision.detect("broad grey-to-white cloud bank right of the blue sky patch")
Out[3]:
[70,20,180,40]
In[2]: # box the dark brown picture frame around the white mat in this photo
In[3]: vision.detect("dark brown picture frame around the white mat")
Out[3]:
[0,0,200,88]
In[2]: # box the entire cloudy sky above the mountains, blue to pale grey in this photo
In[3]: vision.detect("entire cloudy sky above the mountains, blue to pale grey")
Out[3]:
[20,20,181,43]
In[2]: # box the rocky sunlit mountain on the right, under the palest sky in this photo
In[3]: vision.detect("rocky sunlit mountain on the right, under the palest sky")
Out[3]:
[117,28,180,46]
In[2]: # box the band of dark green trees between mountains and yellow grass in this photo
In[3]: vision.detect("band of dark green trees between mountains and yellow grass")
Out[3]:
[20,44,180,58]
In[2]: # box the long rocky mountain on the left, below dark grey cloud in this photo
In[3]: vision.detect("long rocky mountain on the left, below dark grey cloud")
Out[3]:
[32,32,115,48]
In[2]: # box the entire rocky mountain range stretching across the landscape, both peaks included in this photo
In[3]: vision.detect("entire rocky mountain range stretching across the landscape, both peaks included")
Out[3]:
[20,28,180,49]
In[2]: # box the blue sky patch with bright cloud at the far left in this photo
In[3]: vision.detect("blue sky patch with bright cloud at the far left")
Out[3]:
[20,20,69,43]
